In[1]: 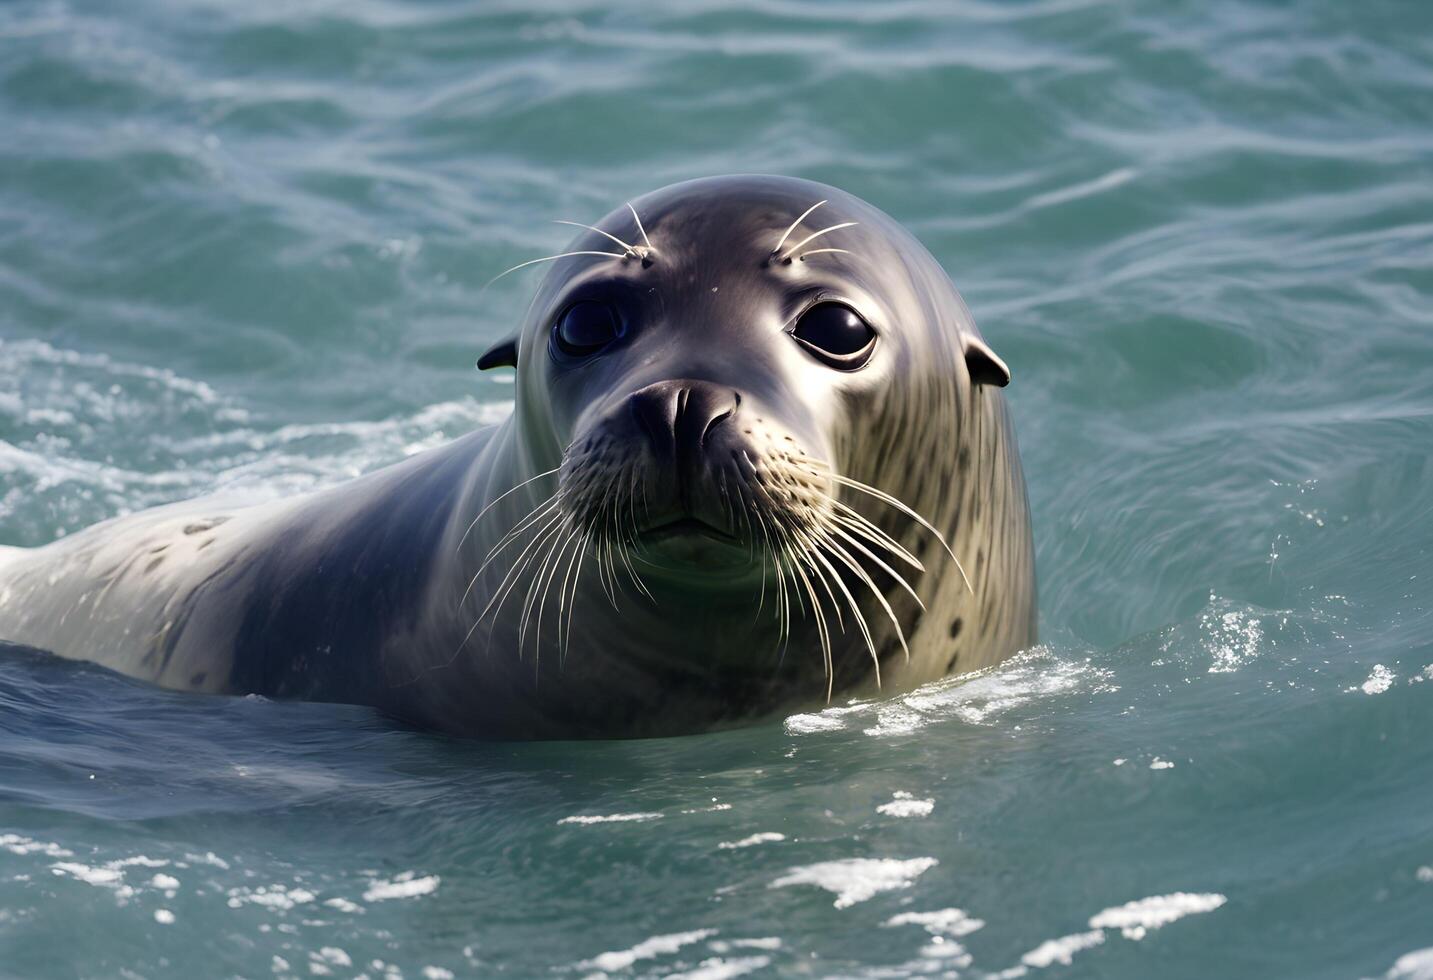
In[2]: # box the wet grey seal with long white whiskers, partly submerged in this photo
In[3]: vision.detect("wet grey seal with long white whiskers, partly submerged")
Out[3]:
[0,176,1036,738]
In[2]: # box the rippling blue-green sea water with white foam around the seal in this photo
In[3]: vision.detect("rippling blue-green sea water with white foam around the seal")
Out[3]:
[0,0,1433,980]
